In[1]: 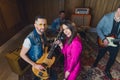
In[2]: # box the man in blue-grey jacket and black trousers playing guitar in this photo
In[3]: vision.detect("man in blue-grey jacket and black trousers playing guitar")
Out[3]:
[92,6,120,80]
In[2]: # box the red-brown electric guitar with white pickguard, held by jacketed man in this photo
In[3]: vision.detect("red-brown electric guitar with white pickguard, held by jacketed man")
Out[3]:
[97,35,120,47]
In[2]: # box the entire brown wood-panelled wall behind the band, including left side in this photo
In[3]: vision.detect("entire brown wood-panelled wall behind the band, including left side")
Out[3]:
[0,0,120,43]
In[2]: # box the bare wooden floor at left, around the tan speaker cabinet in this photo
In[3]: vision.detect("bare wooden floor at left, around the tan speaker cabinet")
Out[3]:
[0,25,33,80]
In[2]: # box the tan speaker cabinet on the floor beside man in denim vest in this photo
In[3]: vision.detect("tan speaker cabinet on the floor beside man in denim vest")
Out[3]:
[5,49,30,75]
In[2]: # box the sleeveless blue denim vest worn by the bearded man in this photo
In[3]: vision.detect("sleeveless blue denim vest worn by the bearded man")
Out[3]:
[27,29,46,62]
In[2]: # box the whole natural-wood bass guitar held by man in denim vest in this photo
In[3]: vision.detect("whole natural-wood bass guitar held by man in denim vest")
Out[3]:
[32,31,62,80]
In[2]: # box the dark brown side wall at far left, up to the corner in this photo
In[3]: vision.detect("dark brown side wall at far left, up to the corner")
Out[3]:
[0,0,24,45]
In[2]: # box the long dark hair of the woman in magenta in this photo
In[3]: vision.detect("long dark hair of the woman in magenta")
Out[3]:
[62,20,77,44]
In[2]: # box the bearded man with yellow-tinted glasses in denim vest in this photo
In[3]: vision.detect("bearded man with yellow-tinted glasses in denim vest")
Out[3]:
[20,16,57,80]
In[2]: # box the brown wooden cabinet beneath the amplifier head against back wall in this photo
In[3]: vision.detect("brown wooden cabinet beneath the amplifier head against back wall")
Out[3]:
[71,14,91,27]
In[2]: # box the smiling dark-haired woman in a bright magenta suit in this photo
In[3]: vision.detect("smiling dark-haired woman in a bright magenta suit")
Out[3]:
[56,21,82,80]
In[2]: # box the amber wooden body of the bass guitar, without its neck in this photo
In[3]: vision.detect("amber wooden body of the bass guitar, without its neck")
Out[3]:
[32,48,55,79]
